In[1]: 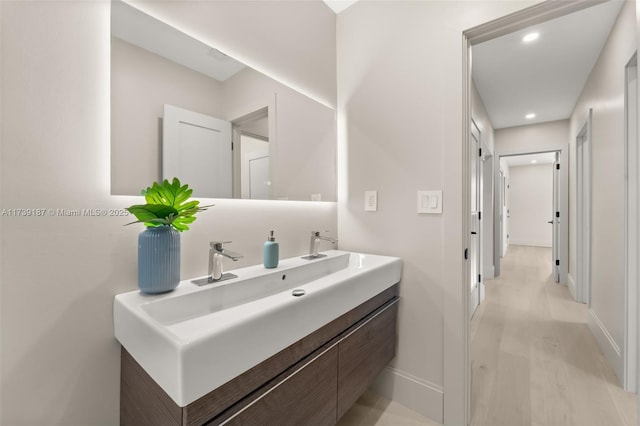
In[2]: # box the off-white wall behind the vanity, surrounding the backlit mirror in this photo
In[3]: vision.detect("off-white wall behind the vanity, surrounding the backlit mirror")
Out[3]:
[0,1,337,426]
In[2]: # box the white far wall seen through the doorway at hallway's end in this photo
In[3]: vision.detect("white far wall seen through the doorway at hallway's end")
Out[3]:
[509,164,553,247]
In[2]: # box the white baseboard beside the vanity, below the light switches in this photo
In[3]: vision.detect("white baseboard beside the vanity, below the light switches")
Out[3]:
[372,367,444,423]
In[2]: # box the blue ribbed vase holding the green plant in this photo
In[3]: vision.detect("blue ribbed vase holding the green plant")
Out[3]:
[138,226,180,293]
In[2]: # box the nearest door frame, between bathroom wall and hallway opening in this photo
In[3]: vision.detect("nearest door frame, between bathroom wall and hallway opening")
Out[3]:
[460,0,606,425]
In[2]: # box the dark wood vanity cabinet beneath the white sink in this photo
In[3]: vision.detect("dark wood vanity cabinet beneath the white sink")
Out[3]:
[120,285,398,426]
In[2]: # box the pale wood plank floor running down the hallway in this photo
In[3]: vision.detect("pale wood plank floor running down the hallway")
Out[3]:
[470,245,636,426]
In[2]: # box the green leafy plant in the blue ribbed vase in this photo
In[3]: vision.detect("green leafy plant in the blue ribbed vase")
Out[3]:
[127,178,213,232]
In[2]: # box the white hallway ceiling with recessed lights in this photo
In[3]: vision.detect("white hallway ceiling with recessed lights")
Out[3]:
[472,0,623,129]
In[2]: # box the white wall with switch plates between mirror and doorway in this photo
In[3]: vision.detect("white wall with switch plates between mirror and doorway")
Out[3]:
[338,1,532,425]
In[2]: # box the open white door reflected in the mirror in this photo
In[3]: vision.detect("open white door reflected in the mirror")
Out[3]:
[162,105,233,198]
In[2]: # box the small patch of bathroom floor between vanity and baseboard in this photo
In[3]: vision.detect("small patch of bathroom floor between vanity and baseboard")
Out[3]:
[338,391,440,426]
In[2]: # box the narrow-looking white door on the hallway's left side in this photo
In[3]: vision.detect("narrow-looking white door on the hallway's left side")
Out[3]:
[469,120,482,316]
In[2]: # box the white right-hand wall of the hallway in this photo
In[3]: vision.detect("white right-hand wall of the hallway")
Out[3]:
[569,2,636,378]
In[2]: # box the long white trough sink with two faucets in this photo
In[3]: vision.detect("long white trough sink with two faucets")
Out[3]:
[113,250,402,407]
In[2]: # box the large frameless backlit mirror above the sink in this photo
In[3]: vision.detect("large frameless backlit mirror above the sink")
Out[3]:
[111,1,336,201]
